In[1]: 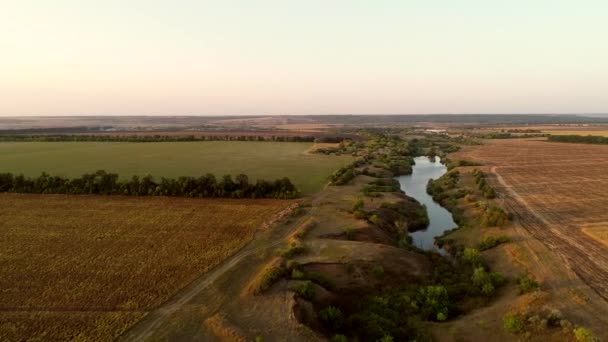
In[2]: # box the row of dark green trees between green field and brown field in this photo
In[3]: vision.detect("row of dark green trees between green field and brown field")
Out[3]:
[0,170,298,198]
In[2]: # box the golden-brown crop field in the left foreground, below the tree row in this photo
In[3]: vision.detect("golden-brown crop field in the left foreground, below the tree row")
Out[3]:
[0,194,293,341]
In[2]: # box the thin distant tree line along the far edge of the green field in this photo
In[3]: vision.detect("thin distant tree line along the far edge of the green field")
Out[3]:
[0,134,347,143]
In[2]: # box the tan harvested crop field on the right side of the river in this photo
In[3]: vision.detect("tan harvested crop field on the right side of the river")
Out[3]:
[455,139,608,299]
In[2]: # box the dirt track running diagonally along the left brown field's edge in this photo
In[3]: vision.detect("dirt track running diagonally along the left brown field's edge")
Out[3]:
[118,211,308,341]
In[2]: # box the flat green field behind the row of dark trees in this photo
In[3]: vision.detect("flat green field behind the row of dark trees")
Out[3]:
[0,141,353,194]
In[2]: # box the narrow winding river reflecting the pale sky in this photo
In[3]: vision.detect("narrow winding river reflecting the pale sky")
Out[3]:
[397,157,458,254]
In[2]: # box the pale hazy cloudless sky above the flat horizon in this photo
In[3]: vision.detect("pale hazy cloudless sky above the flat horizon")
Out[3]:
[0,0,608,116]
